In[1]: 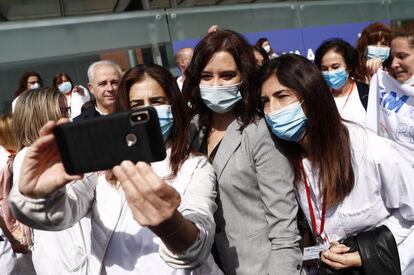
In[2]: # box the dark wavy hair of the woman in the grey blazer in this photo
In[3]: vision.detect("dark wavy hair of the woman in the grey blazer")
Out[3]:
[183,30,258,129]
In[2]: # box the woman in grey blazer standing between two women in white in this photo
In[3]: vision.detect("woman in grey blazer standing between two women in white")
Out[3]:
[183,31,301,275]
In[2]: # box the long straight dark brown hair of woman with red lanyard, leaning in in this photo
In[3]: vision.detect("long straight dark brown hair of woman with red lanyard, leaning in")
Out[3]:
[258,54,354,207]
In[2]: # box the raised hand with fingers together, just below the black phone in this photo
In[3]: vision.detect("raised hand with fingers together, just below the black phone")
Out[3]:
[113,161,181,229]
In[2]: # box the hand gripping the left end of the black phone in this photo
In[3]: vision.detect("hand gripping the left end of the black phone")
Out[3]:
[19,119,82,198]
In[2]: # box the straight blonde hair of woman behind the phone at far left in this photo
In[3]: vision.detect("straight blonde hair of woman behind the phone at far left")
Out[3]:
[13,87,66,151]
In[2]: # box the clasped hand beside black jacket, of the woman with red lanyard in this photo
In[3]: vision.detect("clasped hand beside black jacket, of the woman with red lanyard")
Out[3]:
[321,242,362,270]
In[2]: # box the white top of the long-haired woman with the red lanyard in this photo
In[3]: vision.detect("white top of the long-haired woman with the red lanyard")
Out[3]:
[297,123,414,275]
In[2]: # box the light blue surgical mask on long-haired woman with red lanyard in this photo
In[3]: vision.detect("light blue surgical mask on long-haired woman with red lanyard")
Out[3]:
[265,102,308,141]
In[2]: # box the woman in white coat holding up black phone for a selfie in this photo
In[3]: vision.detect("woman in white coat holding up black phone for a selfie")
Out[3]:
[12,65,221,275]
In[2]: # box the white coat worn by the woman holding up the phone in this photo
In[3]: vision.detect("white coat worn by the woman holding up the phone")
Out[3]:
[10,150,221,275]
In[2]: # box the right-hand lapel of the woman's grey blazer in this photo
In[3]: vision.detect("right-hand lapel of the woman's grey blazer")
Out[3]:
[213,119,242,180]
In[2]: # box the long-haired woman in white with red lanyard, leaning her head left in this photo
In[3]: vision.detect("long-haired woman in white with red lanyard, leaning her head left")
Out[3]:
[259,54,414,275]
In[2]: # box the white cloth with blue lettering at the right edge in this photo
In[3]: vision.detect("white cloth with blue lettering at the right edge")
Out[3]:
[367,70,414,151]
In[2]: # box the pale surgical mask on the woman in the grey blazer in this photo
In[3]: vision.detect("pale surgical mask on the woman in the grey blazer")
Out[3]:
[200,83,242,114]
